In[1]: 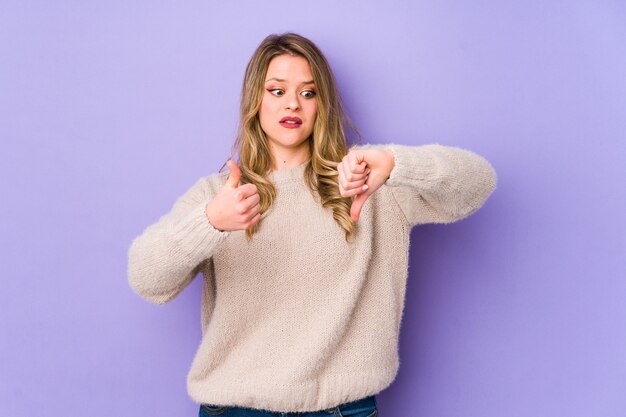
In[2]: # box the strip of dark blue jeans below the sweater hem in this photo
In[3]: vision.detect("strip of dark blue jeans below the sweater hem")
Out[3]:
[198,395,378,417]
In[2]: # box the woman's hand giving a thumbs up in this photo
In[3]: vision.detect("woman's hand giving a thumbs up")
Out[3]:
[205,159,261,232]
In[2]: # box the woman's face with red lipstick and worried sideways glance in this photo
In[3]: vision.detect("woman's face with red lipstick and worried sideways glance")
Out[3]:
[259,55,317,160]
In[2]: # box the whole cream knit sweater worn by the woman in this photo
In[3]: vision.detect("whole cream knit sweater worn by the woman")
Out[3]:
[128,144,496,412]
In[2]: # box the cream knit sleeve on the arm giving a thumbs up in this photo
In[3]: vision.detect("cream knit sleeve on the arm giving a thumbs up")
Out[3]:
[128,174,229,304]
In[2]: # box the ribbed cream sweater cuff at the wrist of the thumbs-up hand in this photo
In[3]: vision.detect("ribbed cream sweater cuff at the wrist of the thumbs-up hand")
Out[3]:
[171,201,230,264]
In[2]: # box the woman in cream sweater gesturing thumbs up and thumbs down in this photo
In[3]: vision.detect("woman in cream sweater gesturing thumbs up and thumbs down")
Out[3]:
[128,33,496,417]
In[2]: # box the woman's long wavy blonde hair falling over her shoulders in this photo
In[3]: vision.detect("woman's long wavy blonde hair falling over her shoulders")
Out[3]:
[222,33,358,241]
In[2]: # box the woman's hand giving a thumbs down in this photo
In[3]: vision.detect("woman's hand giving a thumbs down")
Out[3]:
[337,149,394,221]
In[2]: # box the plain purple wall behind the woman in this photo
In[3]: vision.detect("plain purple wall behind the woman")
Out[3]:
[0,0,626,417]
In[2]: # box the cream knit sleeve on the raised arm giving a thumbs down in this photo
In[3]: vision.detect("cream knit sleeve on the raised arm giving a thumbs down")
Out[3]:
[352,144,497,226]
